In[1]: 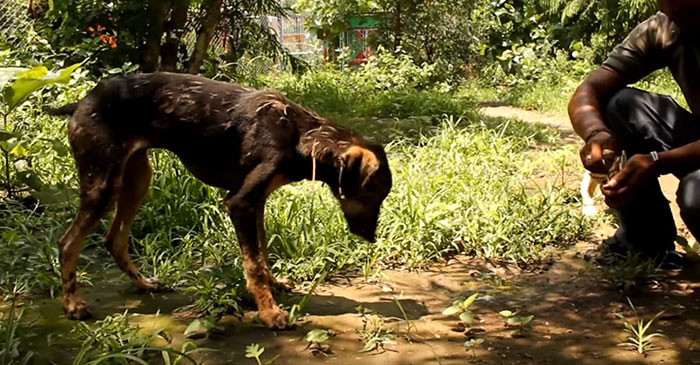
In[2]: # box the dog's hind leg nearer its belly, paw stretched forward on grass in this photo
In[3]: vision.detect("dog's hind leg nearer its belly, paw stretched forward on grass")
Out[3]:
[105,149,160,291]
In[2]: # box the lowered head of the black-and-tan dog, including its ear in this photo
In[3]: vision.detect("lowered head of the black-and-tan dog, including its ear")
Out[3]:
[334,144,391,242]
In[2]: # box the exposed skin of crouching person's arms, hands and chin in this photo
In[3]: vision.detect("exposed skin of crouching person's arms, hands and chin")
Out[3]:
[569,0,700,209]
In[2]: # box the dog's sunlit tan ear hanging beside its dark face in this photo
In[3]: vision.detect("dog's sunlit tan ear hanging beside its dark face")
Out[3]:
[340,145,379,196]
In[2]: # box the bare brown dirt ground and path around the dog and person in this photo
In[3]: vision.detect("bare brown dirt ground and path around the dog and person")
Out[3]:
[16,107,700,365]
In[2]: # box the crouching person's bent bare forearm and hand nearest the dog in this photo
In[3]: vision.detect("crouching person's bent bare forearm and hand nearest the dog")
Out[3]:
[569,66,628,173]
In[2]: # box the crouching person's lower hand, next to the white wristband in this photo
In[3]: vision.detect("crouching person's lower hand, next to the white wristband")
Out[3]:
[601,155,656,209]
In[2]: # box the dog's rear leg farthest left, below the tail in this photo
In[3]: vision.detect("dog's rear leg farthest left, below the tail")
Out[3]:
[59,169,114,319]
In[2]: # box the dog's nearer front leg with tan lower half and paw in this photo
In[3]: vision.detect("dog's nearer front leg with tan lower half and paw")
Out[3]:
[224,164,289,329]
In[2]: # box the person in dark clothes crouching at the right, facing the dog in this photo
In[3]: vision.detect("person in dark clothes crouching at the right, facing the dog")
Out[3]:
[569,0,700,262]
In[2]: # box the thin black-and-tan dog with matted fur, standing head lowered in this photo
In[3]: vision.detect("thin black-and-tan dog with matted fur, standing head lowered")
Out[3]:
[50,73,391,328]
